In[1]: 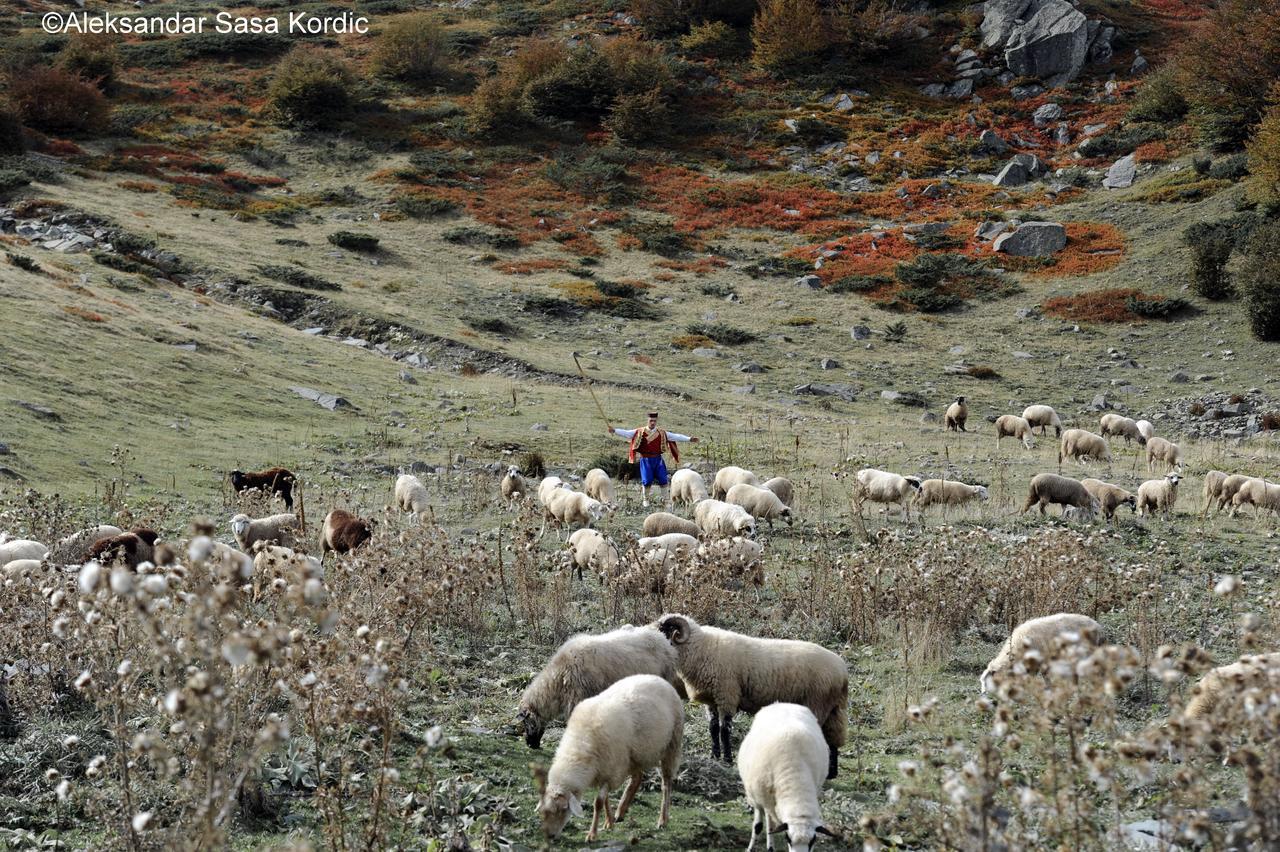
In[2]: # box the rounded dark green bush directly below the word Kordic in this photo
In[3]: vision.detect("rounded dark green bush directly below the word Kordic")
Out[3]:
[266,45,356,128]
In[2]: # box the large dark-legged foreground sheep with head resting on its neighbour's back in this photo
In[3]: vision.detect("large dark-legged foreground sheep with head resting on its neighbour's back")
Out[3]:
[657,613,849,778]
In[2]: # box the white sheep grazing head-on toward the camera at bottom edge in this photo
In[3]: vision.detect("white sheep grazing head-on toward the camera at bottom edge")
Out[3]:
[737,702,835,852]
